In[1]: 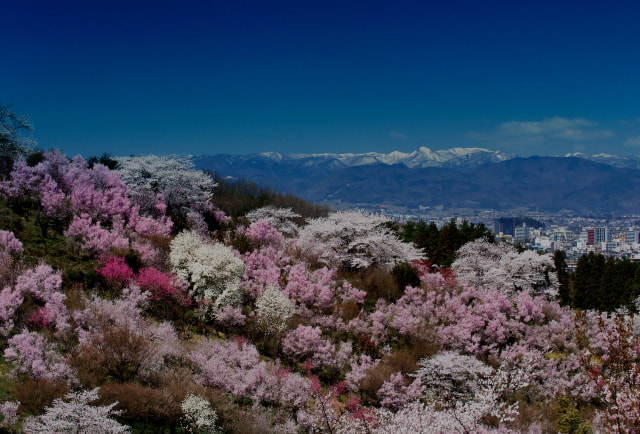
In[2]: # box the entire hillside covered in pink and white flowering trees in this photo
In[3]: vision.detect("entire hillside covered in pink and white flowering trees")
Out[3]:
[0,142,640,433]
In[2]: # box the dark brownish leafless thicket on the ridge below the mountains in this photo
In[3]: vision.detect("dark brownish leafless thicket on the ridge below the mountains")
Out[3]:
[211,173,331,218]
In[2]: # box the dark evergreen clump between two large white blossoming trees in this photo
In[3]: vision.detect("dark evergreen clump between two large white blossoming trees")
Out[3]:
[401,219,494,268]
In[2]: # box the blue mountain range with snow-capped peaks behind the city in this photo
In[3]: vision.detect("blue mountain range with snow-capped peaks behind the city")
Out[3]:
[194,147,640,214]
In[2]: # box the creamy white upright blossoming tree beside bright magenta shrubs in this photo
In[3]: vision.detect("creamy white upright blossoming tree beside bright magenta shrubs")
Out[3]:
[169,231,244,318]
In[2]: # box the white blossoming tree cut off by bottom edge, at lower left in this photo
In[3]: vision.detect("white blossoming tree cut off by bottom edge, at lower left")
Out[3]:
[22,388,130,434]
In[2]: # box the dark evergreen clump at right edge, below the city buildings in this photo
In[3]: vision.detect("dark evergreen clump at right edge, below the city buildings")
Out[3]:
[556,252,640,312]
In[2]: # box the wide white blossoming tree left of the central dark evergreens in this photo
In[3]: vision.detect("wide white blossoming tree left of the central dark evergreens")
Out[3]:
[297,211,424,269]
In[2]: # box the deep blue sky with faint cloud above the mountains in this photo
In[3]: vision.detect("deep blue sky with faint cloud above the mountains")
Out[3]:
[0,0,640,156]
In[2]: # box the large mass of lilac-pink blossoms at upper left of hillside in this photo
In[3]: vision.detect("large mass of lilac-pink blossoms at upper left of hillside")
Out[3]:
[0,151,173,263]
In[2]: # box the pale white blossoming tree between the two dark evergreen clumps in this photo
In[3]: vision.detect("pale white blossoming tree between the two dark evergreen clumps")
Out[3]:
[451,239,558,297]
